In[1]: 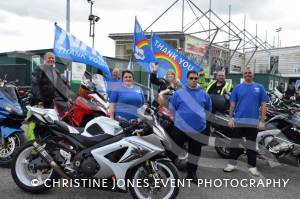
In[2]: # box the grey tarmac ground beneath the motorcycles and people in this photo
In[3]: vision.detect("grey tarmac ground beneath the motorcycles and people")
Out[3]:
[0,146,300,199]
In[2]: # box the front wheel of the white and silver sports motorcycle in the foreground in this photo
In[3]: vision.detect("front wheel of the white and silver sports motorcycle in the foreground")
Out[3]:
[128,160,179,199]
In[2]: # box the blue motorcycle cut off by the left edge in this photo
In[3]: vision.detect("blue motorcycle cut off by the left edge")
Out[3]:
[0,78,25,167]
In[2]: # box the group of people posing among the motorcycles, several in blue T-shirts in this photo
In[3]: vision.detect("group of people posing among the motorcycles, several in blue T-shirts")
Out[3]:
[32,52,268,183]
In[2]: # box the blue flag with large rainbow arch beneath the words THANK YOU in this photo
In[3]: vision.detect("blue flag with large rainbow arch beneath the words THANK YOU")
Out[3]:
[151,34,201,84]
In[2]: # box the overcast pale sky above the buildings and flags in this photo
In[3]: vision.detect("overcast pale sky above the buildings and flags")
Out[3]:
[0,0,300,56]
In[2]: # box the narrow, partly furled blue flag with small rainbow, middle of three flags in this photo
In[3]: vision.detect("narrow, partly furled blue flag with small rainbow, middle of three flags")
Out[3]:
[133,19,155,73]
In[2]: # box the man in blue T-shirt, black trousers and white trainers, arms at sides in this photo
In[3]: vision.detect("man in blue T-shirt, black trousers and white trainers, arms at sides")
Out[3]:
[224,67,268,176]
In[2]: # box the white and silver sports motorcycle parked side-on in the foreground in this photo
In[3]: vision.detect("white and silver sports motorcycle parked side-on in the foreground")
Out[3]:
[11,107,179,198]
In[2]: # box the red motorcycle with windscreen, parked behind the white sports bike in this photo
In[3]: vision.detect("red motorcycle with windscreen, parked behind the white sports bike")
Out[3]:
[54,75,109,127]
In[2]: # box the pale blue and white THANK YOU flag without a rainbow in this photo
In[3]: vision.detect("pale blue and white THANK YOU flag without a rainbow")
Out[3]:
[54,25,111,79]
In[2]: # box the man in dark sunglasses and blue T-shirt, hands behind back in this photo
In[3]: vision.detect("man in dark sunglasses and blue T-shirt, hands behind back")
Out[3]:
[170,71,211,182]
